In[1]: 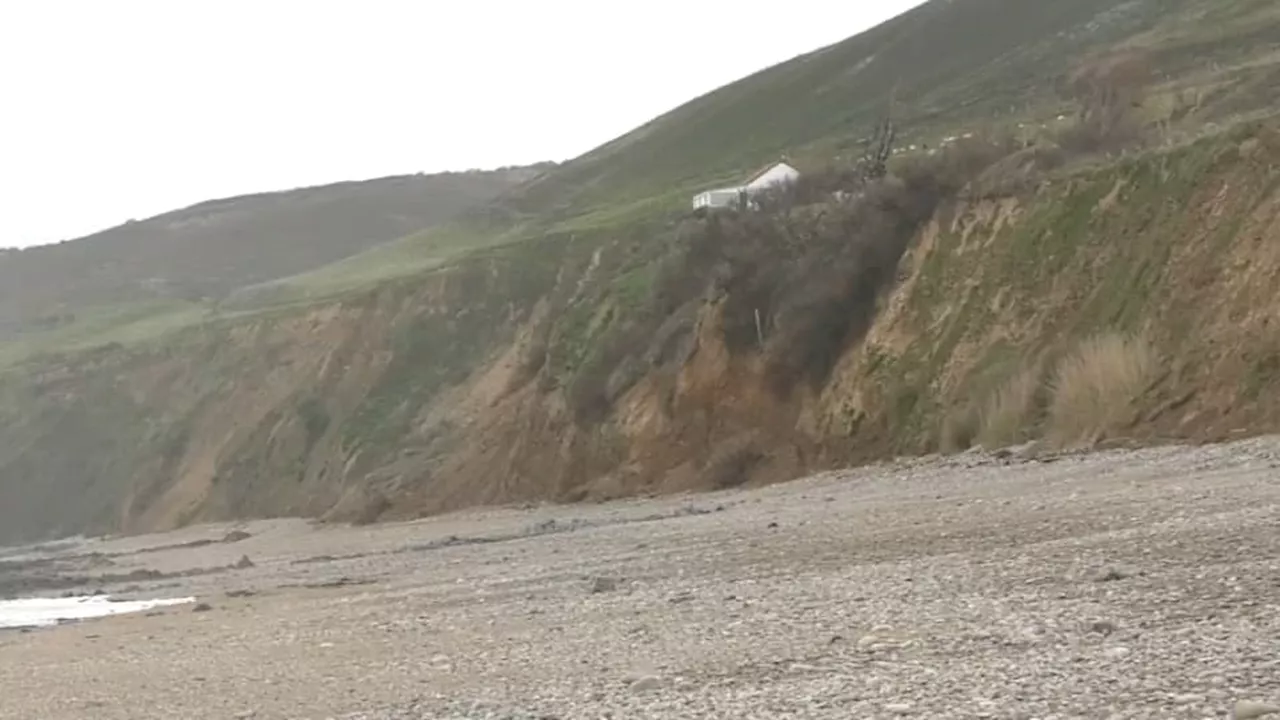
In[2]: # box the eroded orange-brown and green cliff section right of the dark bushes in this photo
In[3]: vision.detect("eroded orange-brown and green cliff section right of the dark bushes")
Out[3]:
[813,122,1280,460]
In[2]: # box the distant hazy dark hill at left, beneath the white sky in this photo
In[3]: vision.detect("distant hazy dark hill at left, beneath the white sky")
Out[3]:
[0,168,545,338]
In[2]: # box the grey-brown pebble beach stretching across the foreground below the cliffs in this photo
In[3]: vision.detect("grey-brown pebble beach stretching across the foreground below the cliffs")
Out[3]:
[0,438,1280,720]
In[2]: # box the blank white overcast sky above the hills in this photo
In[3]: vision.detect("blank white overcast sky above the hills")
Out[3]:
[0,0,920,247]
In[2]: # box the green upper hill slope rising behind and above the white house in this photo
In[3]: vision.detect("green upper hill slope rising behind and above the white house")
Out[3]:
[262,0,1280,301]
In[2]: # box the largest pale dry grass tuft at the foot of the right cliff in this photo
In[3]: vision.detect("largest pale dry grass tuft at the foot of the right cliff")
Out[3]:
[1048,334,1158,447]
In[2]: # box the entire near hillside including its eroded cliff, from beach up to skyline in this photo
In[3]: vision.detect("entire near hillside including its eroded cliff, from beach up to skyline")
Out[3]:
[0,0,1280,541]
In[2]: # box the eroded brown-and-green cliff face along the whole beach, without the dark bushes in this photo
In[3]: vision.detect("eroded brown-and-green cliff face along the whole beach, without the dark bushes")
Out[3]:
[0,122,1280,542]
